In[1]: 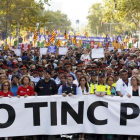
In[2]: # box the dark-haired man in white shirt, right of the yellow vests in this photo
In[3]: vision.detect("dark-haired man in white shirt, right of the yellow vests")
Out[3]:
[116,70,131,97]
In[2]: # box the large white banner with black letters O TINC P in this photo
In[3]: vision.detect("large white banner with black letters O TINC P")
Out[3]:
[0,95,140,137]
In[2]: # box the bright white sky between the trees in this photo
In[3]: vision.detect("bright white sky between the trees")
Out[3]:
[46,0,102,28]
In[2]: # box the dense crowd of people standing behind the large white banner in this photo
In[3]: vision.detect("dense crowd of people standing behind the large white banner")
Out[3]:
[0,47,140,140]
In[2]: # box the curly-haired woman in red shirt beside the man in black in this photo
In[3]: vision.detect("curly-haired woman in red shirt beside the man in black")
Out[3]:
[17,75,34,97]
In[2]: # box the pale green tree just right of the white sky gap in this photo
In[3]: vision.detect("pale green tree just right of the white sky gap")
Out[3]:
[87,3,104,35]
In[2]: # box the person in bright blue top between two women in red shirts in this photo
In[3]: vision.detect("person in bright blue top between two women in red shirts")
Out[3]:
[11,75,19,96]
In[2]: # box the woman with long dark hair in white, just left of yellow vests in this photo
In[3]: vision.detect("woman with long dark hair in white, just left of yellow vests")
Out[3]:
[79,76,89,140]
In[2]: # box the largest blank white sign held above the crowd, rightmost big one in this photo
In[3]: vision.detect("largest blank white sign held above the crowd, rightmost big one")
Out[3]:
[92,48,104,58]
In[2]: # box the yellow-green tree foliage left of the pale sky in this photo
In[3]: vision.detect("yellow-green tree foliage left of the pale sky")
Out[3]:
[0,0,71,35]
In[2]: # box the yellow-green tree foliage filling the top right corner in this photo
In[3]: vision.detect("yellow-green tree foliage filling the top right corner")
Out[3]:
[103,0,140,36]
